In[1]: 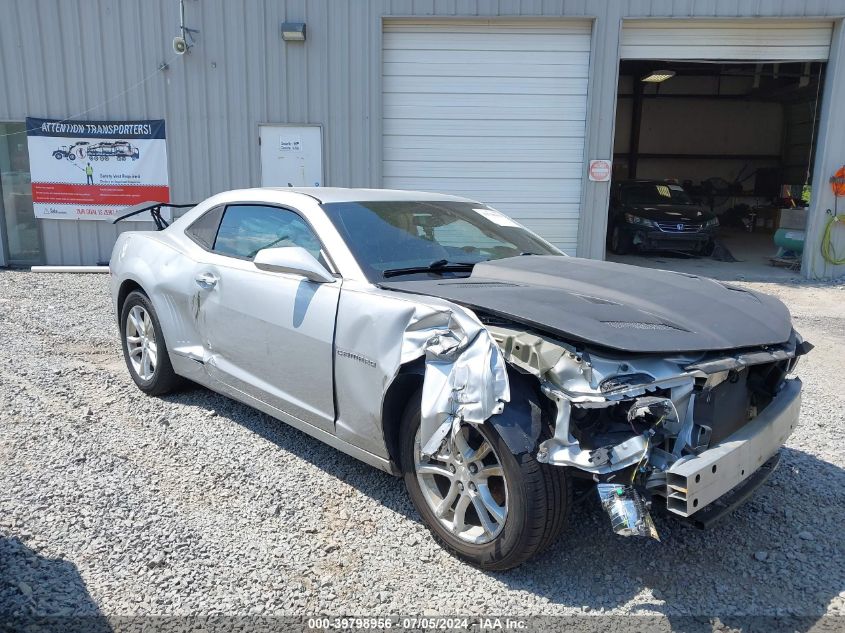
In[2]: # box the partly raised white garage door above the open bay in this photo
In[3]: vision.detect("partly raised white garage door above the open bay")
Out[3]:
[620,19,833,62]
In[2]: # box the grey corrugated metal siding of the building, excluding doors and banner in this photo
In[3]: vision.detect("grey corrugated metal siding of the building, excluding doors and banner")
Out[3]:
[0,0,845,264]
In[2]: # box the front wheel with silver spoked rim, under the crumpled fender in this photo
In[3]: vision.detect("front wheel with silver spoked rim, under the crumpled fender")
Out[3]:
[400,397,571,570]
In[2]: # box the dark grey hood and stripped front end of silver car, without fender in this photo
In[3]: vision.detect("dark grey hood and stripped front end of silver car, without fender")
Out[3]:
[380,257,812,535]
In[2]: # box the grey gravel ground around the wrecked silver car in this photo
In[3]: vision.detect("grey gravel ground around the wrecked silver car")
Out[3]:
[0,271,845,628]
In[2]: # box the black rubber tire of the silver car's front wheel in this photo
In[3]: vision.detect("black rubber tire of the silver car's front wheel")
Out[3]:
[400,393,572,570]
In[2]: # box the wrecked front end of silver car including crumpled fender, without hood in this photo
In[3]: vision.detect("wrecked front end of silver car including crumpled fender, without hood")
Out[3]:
[335,280,812,537]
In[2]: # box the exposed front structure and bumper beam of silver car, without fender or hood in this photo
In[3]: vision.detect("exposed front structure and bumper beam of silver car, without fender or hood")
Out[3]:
[482,318,812,538]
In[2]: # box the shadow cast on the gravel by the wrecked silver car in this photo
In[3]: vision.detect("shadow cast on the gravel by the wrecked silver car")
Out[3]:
[166,388,845,632]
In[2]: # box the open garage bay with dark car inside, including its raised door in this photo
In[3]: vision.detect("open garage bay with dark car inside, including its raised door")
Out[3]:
[607,22,830,280]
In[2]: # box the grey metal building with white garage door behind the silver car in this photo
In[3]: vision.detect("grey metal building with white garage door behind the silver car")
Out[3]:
[0,0,845,277]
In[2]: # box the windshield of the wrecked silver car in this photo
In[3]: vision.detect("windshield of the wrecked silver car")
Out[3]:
[322,201,561,282]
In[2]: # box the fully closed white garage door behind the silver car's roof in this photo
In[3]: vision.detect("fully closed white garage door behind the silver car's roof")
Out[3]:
[383,20,590,254]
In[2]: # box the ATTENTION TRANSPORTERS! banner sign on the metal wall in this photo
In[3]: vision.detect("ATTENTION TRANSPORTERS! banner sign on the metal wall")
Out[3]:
[26,118,170,220]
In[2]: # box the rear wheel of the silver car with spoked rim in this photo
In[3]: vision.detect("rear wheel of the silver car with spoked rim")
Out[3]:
[120,290,182,396]
